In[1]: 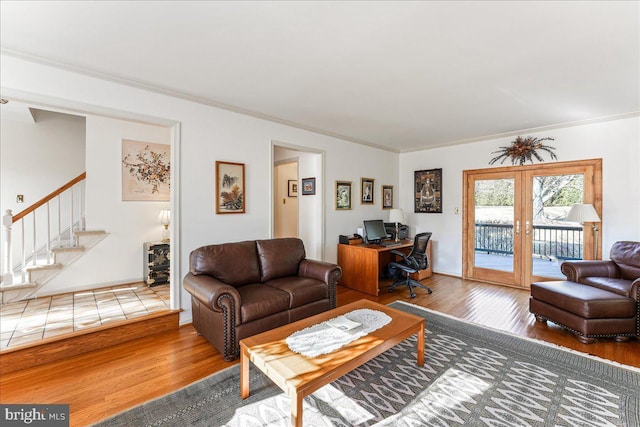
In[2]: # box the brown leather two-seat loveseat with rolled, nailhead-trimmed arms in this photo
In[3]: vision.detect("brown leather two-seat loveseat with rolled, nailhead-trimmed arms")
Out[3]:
[183,238,342,360]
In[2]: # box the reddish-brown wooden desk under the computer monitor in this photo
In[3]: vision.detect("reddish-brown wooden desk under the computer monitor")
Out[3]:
[338,239,431,296]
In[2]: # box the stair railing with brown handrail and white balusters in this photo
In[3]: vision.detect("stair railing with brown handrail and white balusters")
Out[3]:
[2,172,87,285]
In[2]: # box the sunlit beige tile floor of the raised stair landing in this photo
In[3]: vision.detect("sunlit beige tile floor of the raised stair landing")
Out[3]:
[0,283,169,350]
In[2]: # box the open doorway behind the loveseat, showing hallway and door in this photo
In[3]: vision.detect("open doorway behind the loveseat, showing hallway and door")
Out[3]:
[271,142,324,260]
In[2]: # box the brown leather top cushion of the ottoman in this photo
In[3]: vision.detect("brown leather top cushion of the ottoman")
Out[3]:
[531,281,636,319]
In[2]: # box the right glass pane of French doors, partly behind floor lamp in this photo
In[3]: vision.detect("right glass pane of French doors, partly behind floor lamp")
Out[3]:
[526,173,584,279]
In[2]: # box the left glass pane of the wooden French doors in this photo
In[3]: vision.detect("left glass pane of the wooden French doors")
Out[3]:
[474,178,515,272]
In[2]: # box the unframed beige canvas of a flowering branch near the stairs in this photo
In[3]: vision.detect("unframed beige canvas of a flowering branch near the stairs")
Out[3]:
[122,139,171,202]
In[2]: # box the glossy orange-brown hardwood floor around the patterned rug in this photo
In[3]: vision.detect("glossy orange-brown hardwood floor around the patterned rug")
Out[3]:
[0,274,640,426]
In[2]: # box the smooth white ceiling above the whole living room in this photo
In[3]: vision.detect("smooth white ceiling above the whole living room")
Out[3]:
[0,0,640,152]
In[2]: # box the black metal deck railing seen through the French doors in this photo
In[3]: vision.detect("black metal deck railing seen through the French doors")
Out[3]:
[474,222,584,260]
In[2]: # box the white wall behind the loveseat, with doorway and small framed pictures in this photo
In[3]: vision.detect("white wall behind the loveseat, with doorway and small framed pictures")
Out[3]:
[0,54,398,321]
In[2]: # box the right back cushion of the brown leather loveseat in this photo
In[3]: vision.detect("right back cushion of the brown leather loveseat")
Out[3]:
[256,238,305,282]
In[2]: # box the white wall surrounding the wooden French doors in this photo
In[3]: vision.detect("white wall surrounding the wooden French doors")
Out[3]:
[400,117,640,276]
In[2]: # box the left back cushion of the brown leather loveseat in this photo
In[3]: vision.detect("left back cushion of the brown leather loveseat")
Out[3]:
[189,241,260,286]
